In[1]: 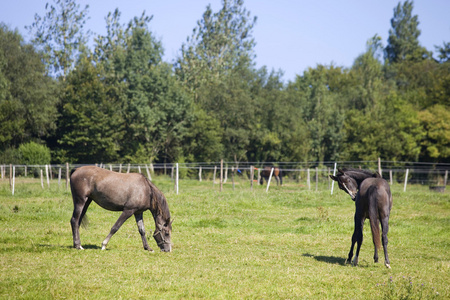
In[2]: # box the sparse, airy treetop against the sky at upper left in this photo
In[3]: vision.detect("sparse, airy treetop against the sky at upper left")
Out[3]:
[27,0,89,80]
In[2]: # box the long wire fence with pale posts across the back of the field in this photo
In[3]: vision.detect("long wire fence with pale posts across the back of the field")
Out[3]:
[0,160,450,194]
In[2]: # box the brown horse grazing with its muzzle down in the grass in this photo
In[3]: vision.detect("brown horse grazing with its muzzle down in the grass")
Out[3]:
[70,166,172,252]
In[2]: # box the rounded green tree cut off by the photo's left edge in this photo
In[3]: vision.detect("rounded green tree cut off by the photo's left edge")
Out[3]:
[0,24,57,150]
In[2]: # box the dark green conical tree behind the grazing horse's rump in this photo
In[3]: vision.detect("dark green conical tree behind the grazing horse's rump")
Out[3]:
[56,52,124,163]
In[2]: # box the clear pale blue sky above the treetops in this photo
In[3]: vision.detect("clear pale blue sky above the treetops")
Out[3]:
[0,0,450,80]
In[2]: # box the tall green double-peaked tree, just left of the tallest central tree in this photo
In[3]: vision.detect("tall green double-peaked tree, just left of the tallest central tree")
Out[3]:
[95,10,192,162]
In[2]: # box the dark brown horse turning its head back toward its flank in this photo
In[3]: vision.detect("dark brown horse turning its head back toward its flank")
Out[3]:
[330,169,392,268]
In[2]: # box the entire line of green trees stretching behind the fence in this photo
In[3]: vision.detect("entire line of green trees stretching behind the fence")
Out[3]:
[0,0,450,163]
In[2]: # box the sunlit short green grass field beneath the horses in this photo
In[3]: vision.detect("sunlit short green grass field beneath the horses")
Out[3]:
[0,177,450,299]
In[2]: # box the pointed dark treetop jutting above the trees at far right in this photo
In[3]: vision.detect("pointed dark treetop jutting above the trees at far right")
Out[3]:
[386,1,431,63]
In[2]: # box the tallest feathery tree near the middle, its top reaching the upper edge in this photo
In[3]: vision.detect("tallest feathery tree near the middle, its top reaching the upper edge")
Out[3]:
[176,0,256,160]
